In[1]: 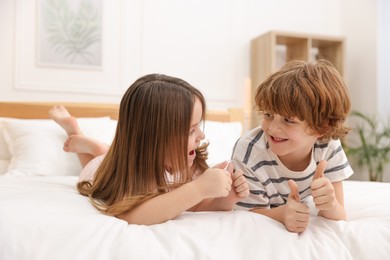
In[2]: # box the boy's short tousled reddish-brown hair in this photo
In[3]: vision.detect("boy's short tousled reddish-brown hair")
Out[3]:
[255,60,351,140]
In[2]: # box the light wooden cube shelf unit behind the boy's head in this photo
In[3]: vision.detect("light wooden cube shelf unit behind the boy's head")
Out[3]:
[251,31,344,128]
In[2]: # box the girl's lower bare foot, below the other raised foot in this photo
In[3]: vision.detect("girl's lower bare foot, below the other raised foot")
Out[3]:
[64,135,109,156]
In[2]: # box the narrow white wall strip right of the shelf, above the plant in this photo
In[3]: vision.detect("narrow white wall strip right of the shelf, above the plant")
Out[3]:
[340,0,378,113]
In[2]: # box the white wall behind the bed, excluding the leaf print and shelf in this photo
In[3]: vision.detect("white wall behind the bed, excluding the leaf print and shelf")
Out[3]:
[0,0,390,181]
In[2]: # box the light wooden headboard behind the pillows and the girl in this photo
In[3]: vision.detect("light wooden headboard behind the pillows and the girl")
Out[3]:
[0,102,244,123]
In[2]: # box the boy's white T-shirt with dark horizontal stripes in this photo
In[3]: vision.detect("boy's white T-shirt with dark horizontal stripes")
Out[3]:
[232,127,353,210]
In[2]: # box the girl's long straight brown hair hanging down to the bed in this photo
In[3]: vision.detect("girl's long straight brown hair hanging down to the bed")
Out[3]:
[77,74,207,216]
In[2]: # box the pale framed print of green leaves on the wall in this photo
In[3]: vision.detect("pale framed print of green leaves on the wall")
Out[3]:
[36,0,103,68]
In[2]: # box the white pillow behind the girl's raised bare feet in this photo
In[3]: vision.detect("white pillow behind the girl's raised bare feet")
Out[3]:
[3,117,116,176]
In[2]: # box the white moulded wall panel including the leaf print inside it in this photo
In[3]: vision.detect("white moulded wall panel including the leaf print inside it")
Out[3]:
[14,0,142,95]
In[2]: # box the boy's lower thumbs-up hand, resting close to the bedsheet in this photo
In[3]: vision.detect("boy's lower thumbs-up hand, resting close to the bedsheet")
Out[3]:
[282,180,309,233]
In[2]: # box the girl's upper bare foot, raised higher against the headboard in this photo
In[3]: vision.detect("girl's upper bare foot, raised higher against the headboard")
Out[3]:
[49,105,82,136]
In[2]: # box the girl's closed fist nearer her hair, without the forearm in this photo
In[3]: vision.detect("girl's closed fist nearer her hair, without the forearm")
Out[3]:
[194,168,232,199]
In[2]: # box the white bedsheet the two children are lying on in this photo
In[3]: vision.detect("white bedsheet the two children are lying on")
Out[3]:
[0,176,390,260]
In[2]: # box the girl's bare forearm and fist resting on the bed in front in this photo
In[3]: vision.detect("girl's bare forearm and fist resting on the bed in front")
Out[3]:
[117,169,232,225]
